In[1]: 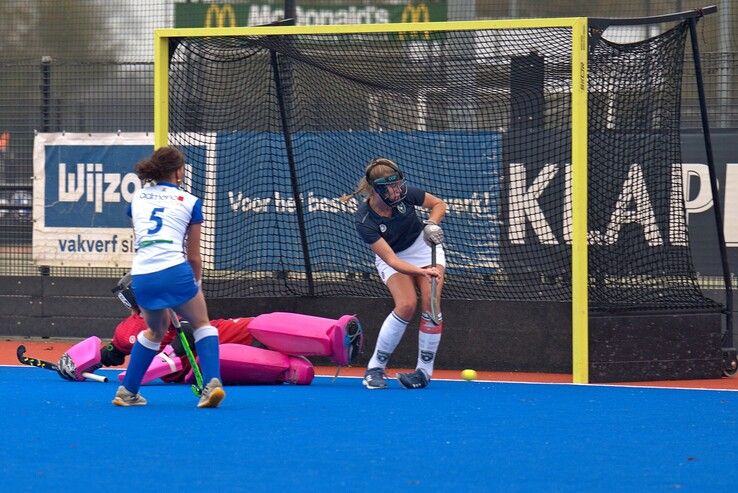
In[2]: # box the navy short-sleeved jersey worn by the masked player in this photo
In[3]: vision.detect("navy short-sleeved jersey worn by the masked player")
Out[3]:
[356,186,425,252]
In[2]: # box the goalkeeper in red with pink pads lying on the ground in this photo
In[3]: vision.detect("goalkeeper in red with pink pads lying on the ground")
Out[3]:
[58,275,363,385]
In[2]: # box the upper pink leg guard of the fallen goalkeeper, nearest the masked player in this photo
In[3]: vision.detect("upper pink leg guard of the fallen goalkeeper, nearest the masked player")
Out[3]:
[248,312,363,366]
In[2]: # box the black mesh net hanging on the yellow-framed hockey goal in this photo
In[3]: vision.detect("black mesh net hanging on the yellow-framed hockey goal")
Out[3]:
[168,24,716,310]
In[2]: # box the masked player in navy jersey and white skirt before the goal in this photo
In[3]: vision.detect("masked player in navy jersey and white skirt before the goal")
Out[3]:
[344,158,446,389]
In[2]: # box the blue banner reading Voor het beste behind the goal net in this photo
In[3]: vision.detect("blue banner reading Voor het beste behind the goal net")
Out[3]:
[214,131,502,272]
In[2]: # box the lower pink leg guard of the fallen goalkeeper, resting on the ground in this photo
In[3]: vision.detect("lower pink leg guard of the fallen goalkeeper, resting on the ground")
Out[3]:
[220,344,315,385]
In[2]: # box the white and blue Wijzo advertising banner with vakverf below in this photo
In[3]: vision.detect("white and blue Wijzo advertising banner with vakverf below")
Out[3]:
[33,133,211,268]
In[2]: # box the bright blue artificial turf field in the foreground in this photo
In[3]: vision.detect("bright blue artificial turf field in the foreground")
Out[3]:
[0,367,738,493]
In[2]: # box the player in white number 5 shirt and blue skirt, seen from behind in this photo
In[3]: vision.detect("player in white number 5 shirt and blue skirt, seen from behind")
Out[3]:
[113,147,225,407]
